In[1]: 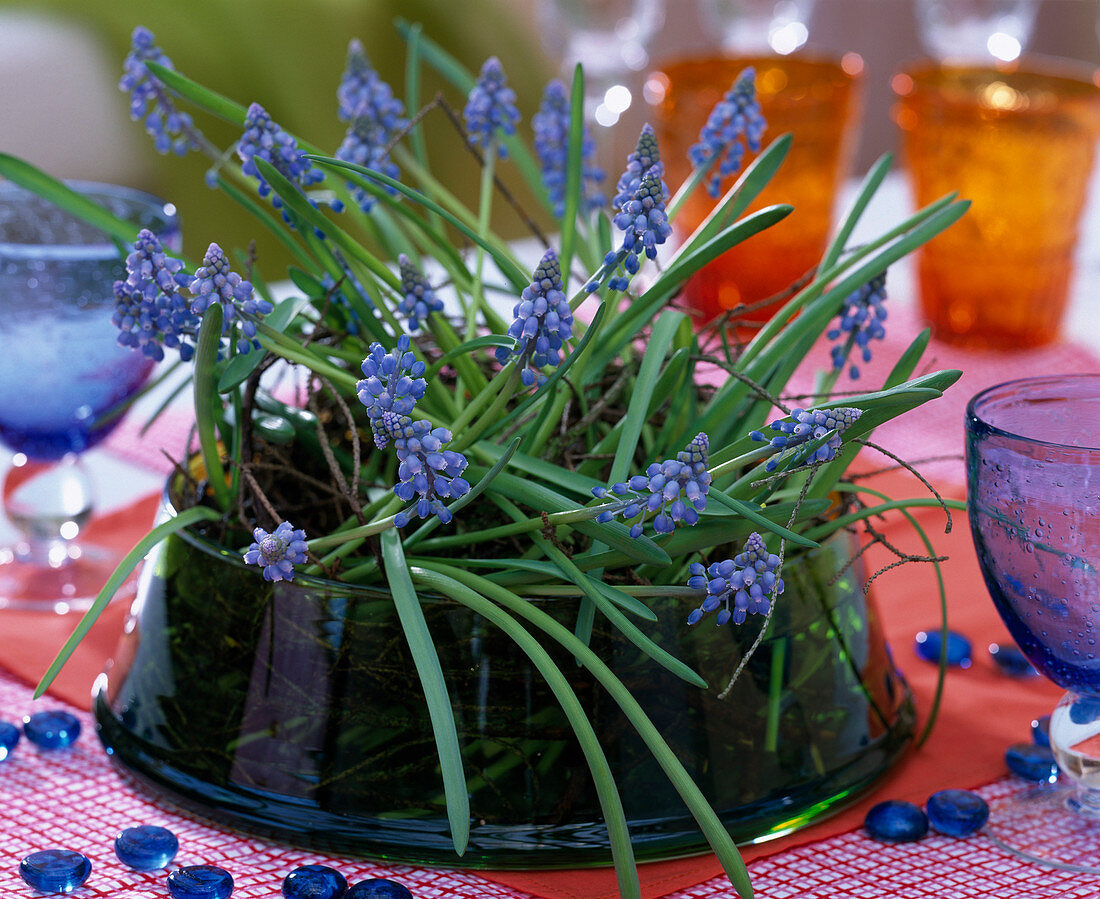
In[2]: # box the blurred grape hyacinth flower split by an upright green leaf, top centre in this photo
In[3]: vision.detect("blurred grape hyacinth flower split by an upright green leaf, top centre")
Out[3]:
[531,79,607,218]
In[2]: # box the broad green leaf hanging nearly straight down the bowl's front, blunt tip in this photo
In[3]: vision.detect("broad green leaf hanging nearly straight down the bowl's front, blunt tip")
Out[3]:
[378,530,470,855]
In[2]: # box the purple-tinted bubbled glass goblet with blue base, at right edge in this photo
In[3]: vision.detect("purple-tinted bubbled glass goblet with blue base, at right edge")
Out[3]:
[966,374,1100,873]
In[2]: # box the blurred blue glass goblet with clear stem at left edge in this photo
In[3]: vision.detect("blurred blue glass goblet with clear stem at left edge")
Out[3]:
[0,183,179,612]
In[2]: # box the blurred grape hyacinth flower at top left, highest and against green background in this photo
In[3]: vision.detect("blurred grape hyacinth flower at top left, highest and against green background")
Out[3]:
[119,25,199,156]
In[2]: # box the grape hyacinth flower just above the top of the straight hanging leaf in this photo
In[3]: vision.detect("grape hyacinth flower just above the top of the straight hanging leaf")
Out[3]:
[387,413,470,527]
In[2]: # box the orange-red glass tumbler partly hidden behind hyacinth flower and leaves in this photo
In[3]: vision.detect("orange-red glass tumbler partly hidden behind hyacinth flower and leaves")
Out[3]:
[647,53,864,324]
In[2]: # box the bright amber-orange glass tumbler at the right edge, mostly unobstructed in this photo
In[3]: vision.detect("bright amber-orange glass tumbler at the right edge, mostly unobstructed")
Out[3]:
[892,62,1100,350]
